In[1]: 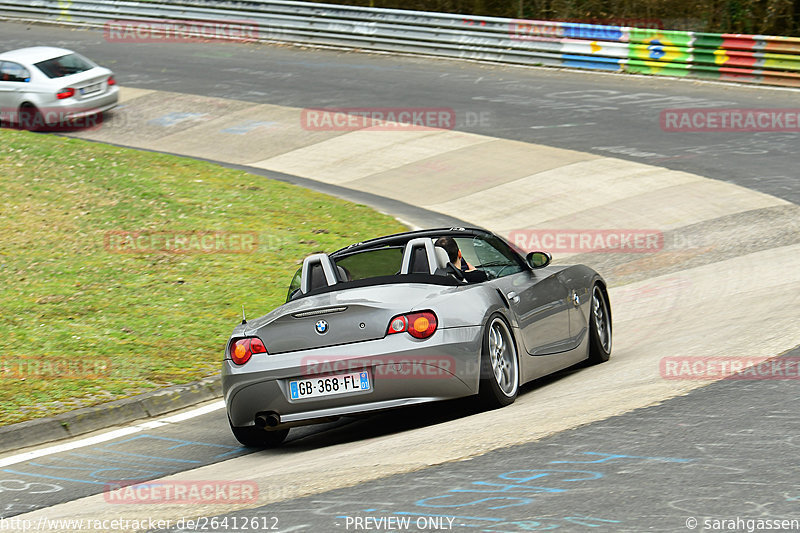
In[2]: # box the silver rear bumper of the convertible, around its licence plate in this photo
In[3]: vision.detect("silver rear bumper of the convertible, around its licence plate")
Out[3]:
[222,326,482,427]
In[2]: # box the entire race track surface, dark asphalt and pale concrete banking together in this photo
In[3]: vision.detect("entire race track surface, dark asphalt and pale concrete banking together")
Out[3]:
[0,23,800,532]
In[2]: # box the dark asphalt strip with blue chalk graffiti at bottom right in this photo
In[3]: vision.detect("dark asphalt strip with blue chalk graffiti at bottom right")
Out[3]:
[155,350,800,533]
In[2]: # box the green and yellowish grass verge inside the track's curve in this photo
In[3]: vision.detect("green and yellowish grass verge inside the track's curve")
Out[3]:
[0,130,404,425]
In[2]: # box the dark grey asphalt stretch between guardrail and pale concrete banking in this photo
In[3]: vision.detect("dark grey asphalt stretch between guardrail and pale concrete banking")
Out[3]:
[0,24,800,203]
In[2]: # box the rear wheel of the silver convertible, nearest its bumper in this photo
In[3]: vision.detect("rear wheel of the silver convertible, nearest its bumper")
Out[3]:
[478,314,519,409]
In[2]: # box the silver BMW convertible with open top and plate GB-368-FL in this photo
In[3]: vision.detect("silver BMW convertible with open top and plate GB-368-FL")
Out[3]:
[222,228,611,446]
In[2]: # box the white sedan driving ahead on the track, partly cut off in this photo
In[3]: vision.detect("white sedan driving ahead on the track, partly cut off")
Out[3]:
[0,46,119,130]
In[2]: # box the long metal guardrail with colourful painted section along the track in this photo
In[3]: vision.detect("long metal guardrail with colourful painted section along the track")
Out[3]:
[0,0,800,87]
